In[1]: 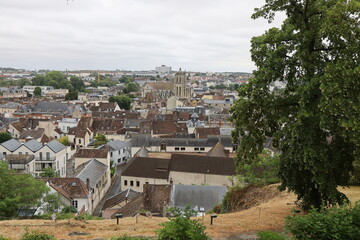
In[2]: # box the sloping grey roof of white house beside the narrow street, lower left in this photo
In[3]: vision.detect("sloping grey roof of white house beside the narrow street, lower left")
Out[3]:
[74,159,108,188]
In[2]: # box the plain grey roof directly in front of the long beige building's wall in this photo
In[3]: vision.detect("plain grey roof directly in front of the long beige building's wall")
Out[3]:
[171,184,226,211]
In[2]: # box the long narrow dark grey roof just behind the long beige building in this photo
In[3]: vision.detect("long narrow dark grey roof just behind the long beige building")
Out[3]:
[132,134,233,147]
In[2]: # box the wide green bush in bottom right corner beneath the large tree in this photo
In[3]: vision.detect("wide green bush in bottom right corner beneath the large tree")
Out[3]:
[286,204,360,240]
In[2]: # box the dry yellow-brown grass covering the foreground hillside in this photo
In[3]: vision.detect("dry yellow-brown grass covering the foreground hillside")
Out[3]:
[0,187,360,239]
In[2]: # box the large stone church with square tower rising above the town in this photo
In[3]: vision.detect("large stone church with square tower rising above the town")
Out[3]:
[142,68,191,100]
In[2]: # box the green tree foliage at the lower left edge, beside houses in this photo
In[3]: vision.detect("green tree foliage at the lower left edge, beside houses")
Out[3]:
[0,162,48,218]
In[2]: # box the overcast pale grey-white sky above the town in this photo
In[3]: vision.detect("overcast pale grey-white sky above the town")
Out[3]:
[0,0,280,72]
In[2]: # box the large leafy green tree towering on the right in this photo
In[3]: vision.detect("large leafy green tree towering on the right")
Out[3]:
[232,0,360,208]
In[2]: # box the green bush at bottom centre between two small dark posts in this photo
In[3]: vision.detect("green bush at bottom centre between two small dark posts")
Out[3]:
[156,207,210,240]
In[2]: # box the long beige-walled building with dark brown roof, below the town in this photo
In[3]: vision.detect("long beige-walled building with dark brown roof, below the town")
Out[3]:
[121,154,235,192]
